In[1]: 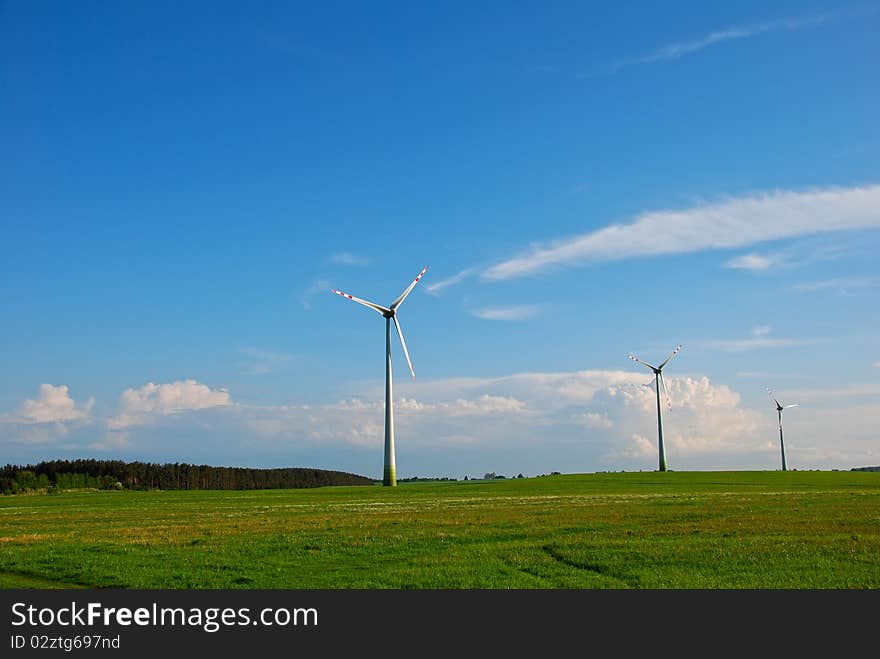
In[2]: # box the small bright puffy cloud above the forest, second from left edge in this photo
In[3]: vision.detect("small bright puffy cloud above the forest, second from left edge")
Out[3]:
[107,380,232,430]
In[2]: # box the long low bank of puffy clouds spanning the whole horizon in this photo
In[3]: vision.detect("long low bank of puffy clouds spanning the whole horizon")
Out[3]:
[0,368,880,475]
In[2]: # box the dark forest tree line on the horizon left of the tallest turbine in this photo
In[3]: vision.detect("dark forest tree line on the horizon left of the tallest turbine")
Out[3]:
[0,459,374,494]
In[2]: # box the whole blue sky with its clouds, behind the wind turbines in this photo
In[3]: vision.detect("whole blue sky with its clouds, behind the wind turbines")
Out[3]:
[0,2,880,478]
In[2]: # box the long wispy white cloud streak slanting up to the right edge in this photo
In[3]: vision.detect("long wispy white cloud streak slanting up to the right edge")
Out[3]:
[482,185,880,281]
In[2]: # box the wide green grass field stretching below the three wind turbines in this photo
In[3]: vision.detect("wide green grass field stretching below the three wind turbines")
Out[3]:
[0,471,880,589]
